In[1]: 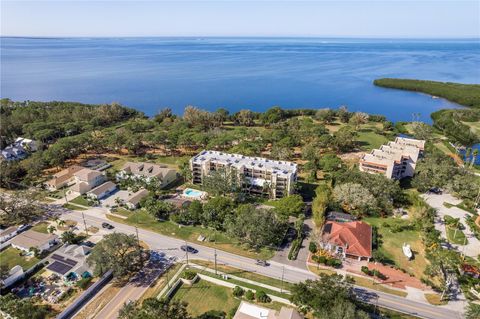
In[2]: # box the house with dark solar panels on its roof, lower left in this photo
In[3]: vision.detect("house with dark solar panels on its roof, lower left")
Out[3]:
[47,245,92,279]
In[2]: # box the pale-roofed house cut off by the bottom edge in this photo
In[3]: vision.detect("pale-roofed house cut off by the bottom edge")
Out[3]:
[233,301,303,319]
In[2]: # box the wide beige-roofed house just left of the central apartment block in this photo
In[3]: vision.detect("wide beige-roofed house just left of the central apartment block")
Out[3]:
[116,162,178,189]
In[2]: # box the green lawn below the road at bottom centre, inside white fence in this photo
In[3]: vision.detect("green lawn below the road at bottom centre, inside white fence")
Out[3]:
[173,280,240,317]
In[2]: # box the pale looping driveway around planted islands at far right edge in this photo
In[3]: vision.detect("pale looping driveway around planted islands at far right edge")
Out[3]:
[421,193,480,257]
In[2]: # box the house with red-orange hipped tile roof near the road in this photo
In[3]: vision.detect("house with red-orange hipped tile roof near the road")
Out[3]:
[321,221,372,261]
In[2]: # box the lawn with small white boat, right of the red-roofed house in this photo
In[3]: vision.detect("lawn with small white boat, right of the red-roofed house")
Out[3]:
[363,217,428,279]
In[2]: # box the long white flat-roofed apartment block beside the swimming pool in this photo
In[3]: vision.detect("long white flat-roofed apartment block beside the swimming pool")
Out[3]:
[190,151,297,199]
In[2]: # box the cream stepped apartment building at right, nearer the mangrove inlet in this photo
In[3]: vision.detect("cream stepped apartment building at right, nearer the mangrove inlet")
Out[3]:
[359,137,425,179]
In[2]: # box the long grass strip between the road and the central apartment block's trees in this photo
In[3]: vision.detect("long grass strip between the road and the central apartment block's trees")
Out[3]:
[107,210,273,259]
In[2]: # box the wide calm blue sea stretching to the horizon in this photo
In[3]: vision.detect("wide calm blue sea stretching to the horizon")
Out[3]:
[0,38,480,122]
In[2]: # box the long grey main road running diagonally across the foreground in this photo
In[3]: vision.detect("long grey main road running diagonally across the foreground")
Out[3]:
[63,209,462,319]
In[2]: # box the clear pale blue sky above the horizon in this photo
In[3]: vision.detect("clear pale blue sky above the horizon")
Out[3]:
[1,0,480,38]
